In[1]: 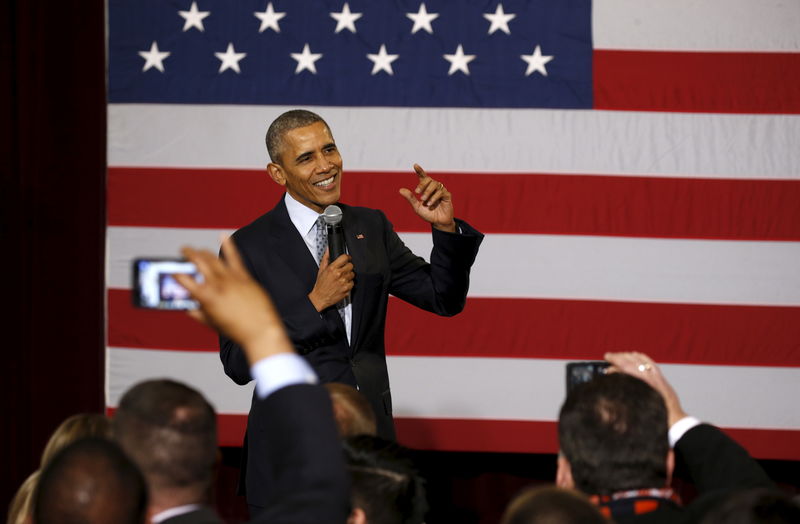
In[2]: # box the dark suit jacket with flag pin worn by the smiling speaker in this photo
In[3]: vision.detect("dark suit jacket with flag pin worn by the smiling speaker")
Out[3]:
[220,197,483,504]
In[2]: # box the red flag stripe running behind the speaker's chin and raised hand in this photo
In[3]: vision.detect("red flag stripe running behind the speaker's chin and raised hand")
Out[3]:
[108,167,800,240]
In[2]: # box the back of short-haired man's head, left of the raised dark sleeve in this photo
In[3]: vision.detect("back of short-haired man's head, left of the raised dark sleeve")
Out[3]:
[112,380,217,515]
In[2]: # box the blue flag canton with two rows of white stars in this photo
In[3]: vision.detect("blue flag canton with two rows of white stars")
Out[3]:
[108,0,592,108]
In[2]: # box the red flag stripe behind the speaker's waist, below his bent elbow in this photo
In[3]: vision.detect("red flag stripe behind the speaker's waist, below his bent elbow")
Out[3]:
[108,289,800,366]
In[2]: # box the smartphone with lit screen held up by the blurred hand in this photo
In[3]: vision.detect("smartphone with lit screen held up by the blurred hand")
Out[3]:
[133,258,202,310]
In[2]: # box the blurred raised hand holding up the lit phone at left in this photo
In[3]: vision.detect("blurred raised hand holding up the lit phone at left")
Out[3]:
[174,238,293,364]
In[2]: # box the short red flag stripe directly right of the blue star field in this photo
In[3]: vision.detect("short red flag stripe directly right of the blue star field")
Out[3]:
[594,49,800,114]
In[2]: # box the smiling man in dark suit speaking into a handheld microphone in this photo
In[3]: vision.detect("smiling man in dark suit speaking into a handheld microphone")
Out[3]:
[220,110,483,512]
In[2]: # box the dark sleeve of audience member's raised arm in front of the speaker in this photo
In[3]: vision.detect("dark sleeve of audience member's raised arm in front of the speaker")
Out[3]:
[248,385,350,524]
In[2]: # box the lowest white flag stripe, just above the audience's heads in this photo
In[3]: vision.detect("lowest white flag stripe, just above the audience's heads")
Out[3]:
[107,347,800,429]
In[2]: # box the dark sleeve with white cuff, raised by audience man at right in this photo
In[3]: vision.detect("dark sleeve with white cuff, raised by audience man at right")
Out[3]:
[675,424,775,494]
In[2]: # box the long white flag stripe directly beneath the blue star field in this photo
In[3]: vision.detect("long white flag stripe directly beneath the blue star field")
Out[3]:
[108,104,800,179]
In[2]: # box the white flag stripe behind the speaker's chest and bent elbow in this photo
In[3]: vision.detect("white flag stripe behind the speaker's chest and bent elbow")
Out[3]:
[108,227,800,306]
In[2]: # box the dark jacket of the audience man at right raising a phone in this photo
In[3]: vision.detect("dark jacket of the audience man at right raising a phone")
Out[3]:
[613,424,775,524]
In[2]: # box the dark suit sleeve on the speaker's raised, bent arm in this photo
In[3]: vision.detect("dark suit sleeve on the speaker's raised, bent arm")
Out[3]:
[381,214,483,316]
